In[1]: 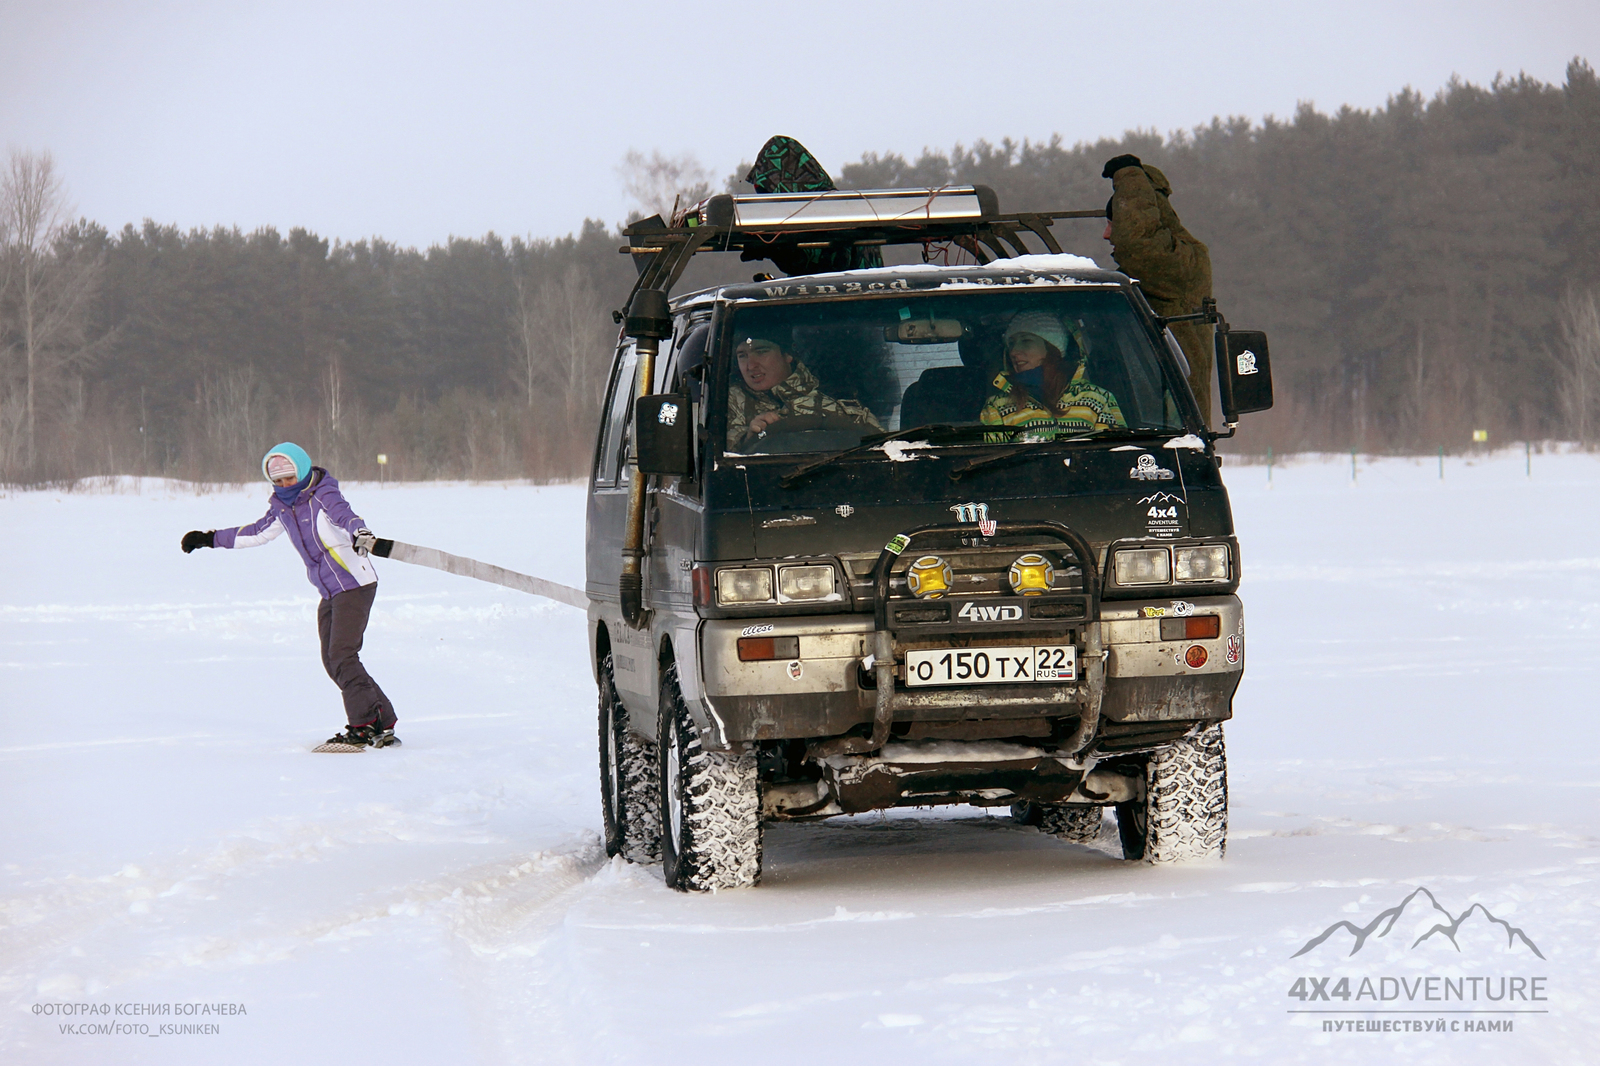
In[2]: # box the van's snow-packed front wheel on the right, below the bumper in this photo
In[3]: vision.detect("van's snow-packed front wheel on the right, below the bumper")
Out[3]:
[1117,725,1227,864]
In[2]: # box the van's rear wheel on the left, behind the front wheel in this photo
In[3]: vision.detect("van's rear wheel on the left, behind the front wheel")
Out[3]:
[600,655,661,863]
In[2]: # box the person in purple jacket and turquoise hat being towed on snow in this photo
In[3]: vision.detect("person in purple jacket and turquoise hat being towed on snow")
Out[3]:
[182,442,400,751]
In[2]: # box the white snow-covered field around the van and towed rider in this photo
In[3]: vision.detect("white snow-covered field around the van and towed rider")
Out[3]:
[0,451,1600,1066]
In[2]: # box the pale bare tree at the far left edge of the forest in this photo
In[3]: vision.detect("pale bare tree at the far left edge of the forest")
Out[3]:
[0,150,101,469]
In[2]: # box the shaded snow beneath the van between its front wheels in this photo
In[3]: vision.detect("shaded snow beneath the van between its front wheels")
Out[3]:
[760,808,1142,893]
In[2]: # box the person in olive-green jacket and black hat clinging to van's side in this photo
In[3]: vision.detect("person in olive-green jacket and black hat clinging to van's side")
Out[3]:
[1101,155,1213,426]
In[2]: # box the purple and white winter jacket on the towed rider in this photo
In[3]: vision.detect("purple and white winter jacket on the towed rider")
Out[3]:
[214,466,378,600]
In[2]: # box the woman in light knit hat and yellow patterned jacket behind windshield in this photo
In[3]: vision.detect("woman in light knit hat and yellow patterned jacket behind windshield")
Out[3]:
[978,311,1128,442]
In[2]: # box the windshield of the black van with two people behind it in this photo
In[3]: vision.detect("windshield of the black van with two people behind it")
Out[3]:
[720,287,1182,453]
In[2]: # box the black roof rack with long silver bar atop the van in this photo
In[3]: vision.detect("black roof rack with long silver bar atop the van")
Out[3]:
[618,186,1106,312]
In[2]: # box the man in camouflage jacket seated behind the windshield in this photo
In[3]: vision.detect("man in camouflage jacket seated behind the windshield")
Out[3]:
[728,335,883,451]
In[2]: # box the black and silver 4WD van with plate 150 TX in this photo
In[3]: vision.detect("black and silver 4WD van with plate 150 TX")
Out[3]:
[587,187,1272,890]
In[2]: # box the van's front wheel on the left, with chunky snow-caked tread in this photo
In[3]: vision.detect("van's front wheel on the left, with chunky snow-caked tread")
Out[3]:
[658,663,762,892]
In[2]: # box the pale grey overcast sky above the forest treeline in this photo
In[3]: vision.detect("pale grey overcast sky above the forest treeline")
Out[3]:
[0,0,1600,245]
